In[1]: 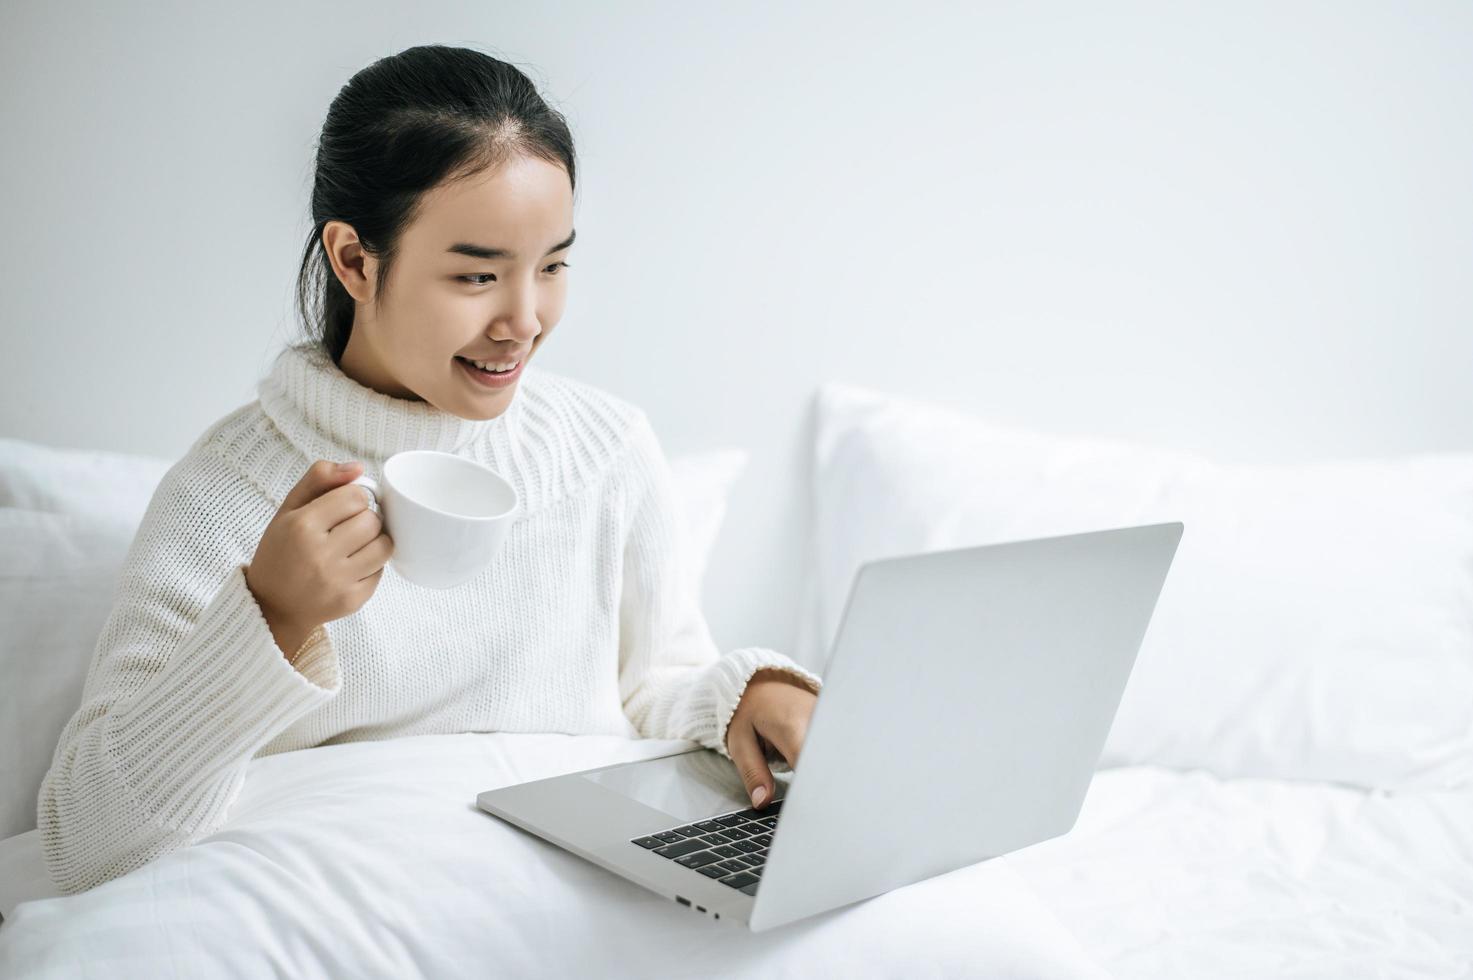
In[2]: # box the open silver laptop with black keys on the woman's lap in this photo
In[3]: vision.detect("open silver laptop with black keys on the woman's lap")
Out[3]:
[476,522,1181,931]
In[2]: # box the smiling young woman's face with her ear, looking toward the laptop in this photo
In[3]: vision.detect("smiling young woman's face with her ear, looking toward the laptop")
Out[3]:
[323,156,573,419]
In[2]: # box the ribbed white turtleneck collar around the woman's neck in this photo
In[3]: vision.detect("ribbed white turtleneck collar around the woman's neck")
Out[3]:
[258,345,532,463]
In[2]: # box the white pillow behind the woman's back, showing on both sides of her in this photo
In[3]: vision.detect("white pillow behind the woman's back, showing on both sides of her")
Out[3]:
[0,439,748,839]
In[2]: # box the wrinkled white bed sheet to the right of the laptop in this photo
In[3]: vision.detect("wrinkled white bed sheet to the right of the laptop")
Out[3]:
[1003,766,1473,980]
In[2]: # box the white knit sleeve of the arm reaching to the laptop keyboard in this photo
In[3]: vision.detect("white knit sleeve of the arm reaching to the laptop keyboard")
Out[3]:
[619,411,822,759]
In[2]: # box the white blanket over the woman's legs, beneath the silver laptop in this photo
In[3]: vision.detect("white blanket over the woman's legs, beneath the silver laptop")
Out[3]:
[0,734,1109,979]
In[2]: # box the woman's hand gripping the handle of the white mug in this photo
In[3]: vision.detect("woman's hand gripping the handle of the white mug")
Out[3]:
[246,460,393,657]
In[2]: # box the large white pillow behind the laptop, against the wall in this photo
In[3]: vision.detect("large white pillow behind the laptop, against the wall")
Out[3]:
[804,383,1473,788]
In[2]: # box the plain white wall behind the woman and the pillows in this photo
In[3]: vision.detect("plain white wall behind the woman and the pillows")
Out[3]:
[0,0,1473,666]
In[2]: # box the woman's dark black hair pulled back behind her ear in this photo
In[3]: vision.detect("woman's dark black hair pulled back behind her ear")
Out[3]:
[296,44,577,363]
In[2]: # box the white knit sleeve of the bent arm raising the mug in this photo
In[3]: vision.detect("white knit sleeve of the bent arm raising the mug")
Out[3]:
[37,445,339,895]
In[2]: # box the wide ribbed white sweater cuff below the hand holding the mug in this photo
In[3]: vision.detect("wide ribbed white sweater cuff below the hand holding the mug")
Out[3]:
[103,564,340,830]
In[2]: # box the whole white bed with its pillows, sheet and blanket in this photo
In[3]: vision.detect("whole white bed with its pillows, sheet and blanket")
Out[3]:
[0,385,1473,977]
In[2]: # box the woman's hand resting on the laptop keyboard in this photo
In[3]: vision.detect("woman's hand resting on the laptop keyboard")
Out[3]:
[726,668,819,809]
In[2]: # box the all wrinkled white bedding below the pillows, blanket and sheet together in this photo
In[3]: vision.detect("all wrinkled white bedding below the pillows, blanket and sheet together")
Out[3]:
[0,734,1473,979]
